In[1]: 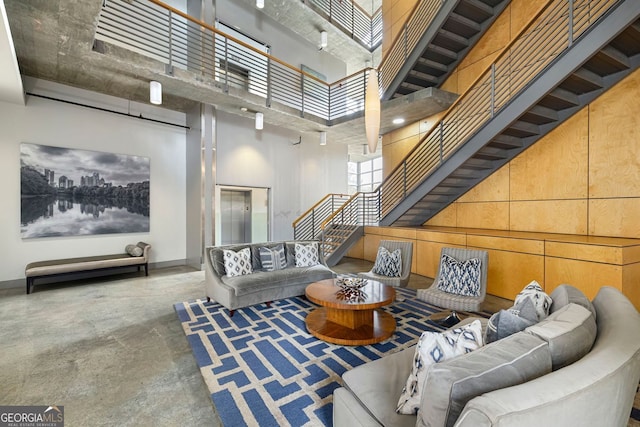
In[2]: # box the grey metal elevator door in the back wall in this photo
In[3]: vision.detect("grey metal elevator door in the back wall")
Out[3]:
[220,190,251,245]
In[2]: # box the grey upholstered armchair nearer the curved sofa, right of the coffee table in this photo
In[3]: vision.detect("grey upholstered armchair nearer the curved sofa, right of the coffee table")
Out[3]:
[417,248,489,325]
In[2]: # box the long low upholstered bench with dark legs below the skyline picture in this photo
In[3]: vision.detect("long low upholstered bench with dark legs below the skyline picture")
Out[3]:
[24,242,151,294]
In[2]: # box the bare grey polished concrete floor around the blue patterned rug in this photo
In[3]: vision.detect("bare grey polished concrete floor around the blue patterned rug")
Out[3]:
[0,259,511,427]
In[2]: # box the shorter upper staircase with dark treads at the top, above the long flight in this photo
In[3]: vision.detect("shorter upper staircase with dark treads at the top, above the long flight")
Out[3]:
[380,0,509,100]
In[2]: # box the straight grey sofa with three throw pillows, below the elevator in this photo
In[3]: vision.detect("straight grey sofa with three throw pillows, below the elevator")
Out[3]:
[205,241,335,315]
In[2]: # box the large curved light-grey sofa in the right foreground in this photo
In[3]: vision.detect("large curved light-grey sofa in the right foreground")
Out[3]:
[333,285,640,427]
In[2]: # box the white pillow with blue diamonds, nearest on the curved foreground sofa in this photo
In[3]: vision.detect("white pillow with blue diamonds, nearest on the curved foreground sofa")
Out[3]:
[396,320,482,415]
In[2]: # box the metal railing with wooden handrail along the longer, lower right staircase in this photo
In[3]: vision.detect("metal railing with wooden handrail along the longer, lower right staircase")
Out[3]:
[374,0,622,219]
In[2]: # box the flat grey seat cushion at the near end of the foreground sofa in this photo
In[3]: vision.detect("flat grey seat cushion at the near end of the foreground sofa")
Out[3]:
[342,347,416,427]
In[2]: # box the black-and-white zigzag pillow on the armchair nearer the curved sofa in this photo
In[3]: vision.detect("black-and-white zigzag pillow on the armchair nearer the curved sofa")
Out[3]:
[438,254,482,297]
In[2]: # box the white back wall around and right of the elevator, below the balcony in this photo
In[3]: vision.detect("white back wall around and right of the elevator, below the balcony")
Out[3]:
[216,111,347,240]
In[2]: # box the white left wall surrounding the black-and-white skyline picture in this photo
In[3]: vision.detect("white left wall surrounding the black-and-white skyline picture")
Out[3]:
[0,80,186,281]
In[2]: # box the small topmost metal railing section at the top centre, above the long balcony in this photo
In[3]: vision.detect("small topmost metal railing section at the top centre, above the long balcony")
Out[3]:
[304,0,382,52]
